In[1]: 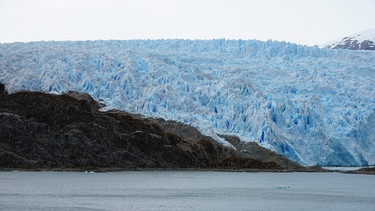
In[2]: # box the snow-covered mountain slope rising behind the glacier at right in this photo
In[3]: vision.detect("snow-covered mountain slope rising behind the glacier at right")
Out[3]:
[321,28,375,50]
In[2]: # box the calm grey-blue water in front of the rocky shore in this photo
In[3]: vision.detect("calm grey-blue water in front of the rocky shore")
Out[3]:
[0,171,375,210]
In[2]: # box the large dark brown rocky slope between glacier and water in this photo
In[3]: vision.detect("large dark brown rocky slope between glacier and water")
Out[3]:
[0,85,290,169]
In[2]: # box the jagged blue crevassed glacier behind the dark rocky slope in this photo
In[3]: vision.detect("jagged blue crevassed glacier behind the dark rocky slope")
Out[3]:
[0,39,375,166]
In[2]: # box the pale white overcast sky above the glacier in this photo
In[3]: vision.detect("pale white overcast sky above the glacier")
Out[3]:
[0,0,375,45]
